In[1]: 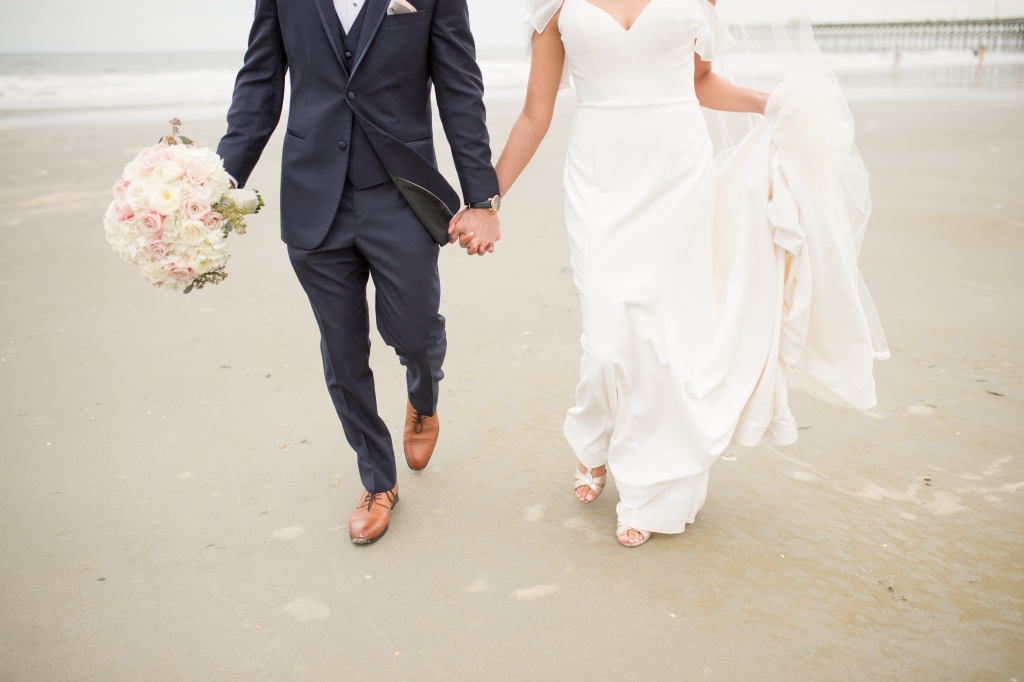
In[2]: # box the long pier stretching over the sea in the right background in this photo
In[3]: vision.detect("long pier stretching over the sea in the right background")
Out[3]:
[732,17,1024,52]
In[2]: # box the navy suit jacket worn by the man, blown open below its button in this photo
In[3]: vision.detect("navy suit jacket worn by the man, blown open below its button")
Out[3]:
[217,0,498,249]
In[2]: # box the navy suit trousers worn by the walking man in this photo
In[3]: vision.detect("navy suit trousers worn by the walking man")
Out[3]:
[288,180,447,493]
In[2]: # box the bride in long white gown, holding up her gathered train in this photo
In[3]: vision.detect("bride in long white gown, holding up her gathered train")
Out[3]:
[451,0,888,547]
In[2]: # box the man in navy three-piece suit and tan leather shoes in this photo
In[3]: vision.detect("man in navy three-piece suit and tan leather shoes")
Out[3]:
[217,0,500,544]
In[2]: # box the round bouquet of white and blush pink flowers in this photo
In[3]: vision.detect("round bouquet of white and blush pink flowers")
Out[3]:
[103,119,263,294]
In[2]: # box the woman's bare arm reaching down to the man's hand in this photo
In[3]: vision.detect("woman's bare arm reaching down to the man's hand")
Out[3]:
[495,10,565,197]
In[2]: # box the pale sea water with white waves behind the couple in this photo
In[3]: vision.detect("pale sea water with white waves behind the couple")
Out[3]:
[0,49,1024,128]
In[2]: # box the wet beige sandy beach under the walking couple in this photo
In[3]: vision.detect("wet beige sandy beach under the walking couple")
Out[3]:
[0,91,1024,682]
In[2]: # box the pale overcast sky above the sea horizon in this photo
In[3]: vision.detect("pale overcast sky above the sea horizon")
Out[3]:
[0,0,1024,52]
